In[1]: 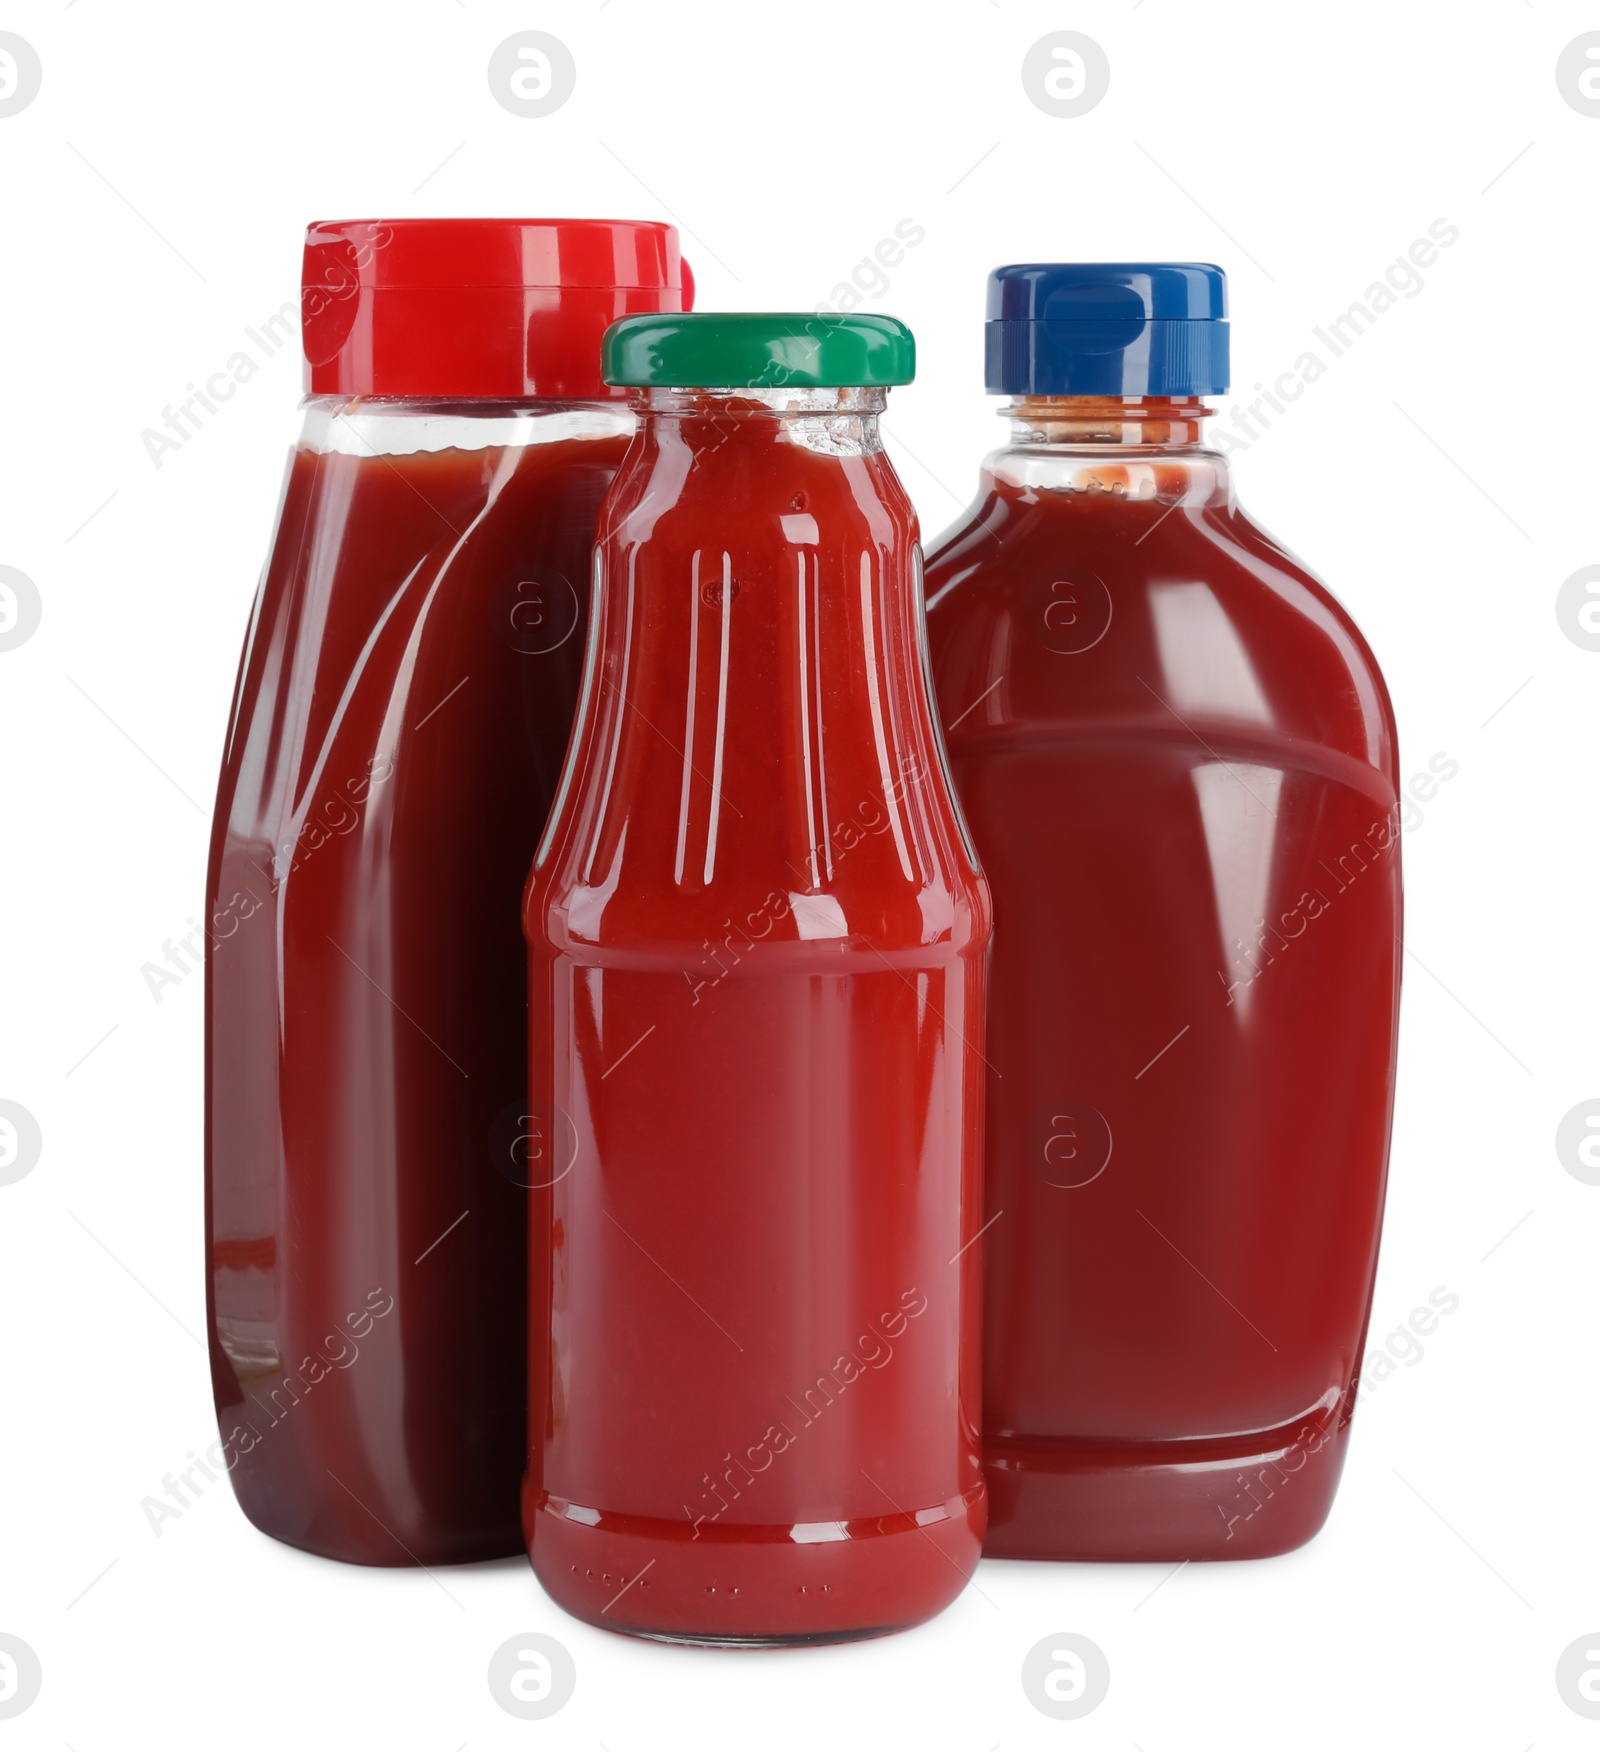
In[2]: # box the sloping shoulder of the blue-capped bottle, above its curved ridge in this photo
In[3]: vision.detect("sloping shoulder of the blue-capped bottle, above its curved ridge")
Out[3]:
[927,485,1397,787]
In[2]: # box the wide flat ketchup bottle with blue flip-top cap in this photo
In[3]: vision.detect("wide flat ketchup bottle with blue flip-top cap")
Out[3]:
[927,263,1400,1559]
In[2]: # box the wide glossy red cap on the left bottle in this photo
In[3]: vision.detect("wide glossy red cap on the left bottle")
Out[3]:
[300,219,694,401]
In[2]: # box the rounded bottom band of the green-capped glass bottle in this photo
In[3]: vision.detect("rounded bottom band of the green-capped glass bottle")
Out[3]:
[524,1484,985,1649]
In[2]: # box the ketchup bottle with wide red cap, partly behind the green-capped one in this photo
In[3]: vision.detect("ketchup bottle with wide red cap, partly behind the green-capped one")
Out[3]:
[203,219,690,1565]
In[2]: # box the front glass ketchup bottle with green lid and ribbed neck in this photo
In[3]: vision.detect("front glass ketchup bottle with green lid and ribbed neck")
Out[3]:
[524,315,988,1643]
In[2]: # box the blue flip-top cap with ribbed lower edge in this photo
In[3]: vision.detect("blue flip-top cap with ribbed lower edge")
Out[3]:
[983,261,1228,396]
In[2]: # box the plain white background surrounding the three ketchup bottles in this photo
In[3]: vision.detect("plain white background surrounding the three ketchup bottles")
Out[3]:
[0,0,1600,1752]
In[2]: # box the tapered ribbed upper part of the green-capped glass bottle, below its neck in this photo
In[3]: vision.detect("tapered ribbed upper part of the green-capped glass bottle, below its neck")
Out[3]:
[524,424,987,965]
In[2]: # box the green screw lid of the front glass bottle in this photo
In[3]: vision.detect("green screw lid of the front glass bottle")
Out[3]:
[599,310,917,389]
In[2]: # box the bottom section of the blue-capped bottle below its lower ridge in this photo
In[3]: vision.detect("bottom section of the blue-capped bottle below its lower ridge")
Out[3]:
[983,1417,1349,1563]
